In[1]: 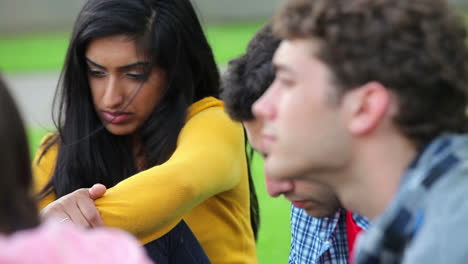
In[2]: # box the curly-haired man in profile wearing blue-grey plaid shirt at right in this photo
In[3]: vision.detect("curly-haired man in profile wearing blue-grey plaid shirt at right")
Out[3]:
[253,0,468,264]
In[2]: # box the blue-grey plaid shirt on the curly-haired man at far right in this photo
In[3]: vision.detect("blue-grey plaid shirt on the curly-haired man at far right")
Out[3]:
[355,135,462,264]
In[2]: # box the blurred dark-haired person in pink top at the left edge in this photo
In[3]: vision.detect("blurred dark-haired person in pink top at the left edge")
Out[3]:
[0,75,151,264]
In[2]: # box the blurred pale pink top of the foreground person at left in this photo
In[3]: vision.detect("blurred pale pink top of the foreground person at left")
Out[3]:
[0,221,152,264]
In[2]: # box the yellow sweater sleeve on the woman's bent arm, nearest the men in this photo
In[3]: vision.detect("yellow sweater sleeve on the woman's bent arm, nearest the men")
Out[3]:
[96,107,245,243]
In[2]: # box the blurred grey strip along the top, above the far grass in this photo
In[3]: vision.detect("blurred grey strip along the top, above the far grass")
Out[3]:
[0,0,282,34]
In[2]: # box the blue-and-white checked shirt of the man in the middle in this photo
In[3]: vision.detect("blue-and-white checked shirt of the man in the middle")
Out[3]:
[288,206,369,264]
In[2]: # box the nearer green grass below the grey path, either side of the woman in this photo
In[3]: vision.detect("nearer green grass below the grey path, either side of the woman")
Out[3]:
[28,129,290,264]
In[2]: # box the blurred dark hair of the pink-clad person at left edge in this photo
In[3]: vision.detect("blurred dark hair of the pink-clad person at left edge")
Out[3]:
[0,75,39,234]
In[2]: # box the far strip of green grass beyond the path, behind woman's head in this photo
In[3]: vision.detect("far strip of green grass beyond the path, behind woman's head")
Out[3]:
[0,22,263,73]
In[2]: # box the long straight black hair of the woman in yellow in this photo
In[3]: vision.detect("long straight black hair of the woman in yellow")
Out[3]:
[40,0,256,238]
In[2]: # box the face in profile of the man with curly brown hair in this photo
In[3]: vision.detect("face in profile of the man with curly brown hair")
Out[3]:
[253,39,351,181]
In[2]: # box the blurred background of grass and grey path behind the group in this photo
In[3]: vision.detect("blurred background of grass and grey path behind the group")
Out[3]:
[0,0,468,263]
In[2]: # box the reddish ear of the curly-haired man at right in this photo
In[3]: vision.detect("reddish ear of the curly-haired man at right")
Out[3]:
[344,82,391,135]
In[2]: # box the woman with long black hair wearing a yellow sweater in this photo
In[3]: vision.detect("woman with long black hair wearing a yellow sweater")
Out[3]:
[34,0,258,263]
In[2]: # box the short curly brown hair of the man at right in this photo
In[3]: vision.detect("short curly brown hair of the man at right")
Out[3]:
[273,0,468,146]
